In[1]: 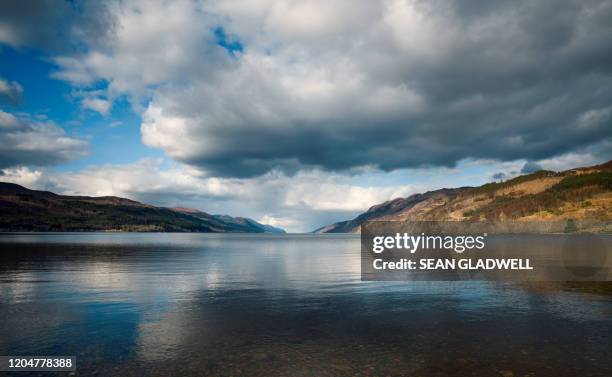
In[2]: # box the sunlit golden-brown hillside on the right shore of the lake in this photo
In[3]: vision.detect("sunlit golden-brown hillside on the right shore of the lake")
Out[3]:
[314,161,612,233]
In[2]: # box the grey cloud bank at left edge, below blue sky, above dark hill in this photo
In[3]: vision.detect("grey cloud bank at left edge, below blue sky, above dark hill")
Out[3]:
[0,110,88,168]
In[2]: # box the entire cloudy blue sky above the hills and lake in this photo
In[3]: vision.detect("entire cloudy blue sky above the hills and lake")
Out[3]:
[0,0,612,232]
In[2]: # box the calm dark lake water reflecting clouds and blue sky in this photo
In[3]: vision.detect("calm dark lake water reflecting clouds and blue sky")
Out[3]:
[0,233,612,376]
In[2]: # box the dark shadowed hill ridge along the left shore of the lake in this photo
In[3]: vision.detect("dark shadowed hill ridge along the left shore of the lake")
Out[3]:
[0,182,284,233]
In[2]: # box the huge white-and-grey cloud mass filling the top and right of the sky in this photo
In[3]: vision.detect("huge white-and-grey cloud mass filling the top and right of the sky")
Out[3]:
[34,0,612,177]
